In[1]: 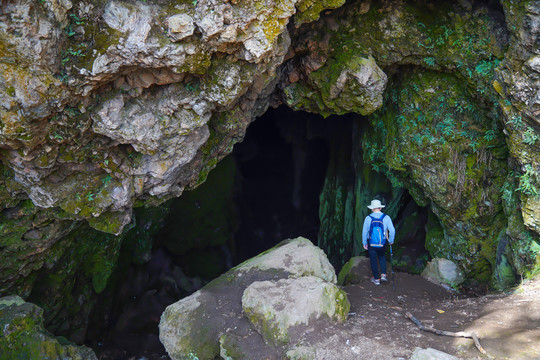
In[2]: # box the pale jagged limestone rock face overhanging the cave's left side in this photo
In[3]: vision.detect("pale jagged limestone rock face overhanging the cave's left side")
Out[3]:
[0,0,343,306]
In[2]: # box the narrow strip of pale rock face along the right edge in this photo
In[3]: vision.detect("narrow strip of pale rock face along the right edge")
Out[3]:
[500,1,540,236]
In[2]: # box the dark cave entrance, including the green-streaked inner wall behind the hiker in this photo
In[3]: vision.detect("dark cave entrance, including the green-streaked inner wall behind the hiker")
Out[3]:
[154,106,437,283]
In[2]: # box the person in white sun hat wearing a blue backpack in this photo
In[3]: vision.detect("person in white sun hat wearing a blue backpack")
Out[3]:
[362,200,396,285]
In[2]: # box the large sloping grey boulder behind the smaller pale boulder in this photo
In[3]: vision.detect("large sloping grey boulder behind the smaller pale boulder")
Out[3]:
[159,238,340,360]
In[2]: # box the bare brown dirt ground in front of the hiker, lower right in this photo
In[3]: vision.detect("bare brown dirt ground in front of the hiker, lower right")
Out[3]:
[98,262,540,360]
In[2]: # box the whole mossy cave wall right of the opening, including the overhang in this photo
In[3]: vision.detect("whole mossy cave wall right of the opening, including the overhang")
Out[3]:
[280,1,538,287]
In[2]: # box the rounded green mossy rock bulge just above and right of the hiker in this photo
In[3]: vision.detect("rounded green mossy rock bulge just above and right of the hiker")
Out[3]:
[364,66,508,282]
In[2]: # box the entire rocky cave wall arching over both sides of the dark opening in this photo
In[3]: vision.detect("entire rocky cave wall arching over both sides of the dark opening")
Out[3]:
[0,0,540,350]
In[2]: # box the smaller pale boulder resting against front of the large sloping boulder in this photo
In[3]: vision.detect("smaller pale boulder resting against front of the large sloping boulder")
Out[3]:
[242,276,350,345]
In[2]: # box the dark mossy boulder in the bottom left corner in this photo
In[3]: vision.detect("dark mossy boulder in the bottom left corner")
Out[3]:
[0,296,97,360]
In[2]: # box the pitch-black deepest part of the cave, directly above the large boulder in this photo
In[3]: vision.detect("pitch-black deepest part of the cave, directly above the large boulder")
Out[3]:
[233,108,329,261]
